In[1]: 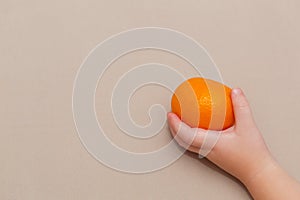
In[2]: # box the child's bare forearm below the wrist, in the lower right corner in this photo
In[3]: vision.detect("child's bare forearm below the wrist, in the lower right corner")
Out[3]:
[243,162,300,200]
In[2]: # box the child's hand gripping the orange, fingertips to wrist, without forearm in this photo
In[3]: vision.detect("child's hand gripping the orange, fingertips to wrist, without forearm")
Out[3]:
[168,89,272,181]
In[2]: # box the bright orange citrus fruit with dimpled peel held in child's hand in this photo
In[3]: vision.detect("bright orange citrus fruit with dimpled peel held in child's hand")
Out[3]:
[171,77,234,130]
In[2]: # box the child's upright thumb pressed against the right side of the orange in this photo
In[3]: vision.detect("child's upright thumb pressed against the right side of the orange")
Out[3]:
[231,88,255,129]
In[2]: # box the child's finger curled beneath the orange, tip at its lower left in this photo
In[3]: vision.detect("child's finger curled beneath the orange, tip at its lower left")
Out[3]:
[168,113,206,148]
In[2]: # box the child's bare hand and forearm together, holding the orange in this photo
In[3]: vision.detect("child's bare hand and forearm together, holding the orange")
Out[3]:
[168,88,300,200]
